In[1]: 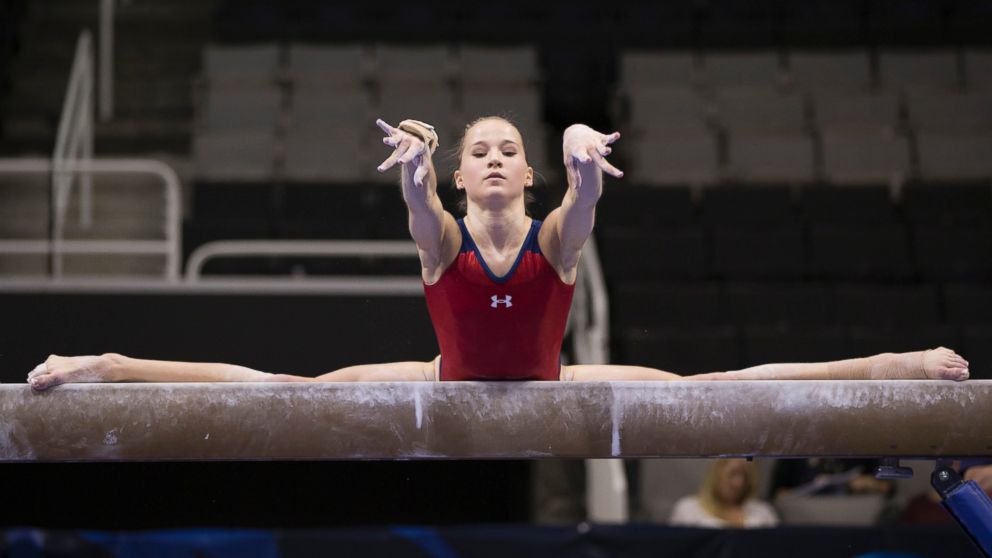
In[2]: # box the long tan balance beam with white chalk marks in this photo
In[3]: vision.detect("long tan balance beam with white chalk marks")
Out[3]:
[0,381,992,462]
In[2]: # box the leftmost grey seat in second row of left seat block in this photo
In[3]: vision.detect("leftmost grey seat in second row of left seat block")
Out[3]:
[198,85,282,132]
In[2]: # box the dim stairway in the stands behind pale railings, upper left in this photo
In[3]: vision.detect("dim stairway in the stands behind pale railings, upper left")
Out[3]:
[0,0,215,276]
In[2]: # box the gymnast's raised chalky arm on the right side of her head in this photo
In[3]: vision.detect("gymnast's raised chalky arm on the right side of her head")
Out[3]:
[541,124,623,283]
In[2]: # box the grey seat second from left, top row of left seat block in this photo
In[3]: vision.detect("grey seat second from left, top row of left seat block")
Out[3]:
[288,43,369,88]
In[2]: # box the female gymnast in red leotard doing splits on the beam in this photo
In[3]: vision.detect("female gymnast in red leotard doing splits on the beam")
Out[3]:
[28,117,968,390]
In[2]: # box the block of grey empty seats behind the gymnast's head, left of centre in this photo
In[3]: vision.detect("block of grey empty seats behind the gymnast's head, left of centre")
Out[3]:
[193,43,547,181]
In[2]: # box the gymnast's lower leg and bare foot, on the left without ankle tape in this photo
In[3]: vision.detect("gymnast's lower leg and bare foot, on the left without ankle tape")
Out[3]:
[28,353,306,390]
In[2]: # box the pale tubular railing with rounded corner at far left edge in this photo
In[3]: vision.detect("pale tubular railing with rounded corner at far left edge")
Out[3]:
[0,157,182,281]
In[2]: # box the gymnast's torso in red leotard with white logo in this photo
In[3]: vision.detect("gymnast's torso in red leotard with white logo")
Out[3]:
[424,219,575,381]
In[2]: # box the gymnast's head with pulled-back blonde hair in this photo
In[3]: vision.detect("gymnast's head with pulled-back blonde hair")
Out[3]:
[455,118,534,210]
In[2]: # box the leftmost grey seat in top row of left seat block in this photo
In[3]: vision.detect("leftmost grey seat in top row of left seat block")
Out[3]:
[203,43,281,84]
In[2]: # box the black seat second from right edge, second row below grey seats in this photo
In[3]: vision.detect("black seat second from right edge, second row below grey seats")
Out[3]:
[809,223,913,280]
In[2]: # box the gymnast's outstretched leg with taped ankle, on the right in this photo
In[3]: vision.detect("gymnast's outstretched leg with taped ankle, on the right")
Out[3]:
[561,347,969,381]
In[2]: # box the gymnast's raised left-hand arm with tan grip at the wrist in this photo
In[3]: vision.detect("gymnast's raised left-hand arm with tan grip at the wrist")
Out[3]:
[376,119,461,283]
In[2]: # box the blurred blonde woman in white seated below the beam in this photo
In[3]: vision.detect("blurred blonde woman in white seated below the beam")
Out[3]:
[669,459,778,528]
